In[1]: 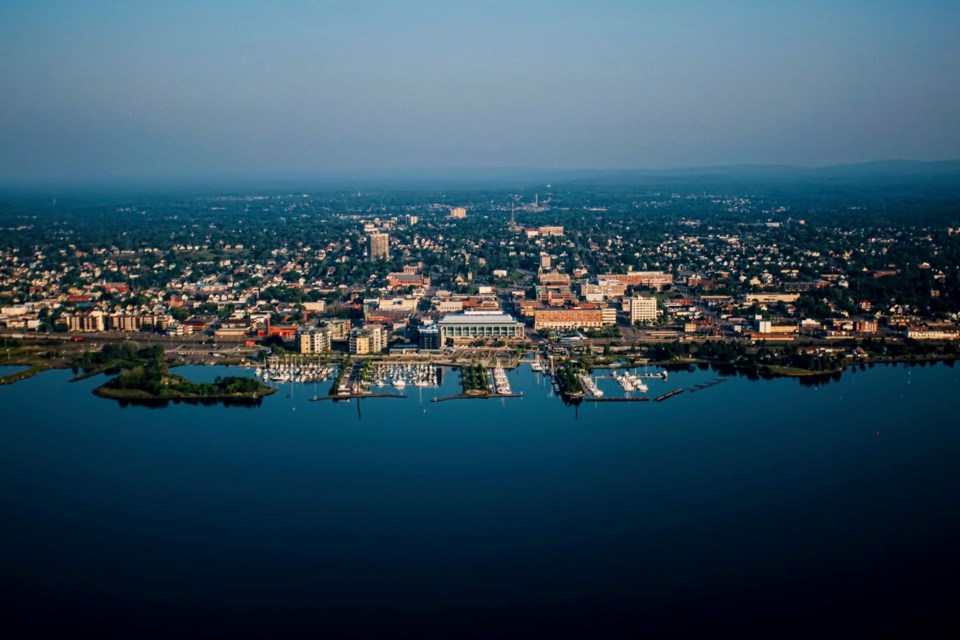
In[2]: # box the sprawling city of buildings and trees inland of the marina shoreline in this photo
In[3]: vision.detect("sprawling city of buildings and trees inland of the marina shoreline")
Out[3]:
[0,188,958,353]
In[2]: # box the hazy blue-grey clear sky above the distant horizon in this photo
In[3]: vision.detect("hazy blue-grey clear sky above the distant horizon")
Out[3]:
[0,0,960,182]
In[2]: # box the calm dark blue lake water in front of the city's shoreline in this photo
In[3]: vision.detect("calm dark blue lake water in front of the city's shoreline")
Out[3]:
[0,365,960,638]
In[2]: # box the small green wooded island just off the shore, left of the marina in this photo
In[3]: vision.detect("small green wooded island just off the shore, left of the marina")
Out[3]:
[81,342,277,404]
